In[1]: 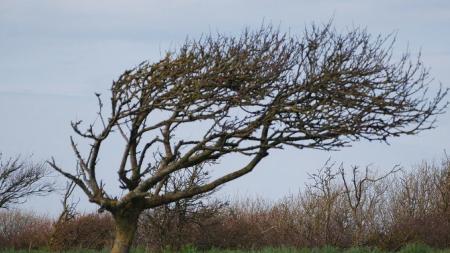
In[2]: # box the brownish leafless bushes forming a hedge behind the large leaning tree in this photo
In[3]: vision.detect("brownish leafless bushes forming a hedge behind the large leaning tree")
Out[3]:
[0,158,450,252]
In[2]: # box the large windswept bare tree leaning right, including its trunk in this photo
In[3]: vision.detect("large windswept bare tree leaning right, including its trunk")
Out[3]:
[49,24,447,253]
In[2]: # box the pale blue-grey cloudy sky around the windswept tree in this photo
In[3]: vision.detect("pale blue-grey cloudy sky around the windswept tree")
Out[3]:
[0,0,450,215]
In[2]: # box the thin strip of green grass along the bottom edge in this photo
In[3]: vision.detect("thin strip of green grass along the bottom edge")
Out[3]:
[0,244,450,253]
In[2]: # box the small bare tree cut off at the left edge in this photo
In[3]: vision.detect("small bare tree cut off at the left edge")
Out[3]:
[0,153,53,209]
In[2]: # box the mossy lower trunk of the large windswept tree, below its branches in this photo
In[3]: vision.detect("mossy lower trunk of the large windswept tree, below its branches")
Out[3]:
[111,210,140,253]
